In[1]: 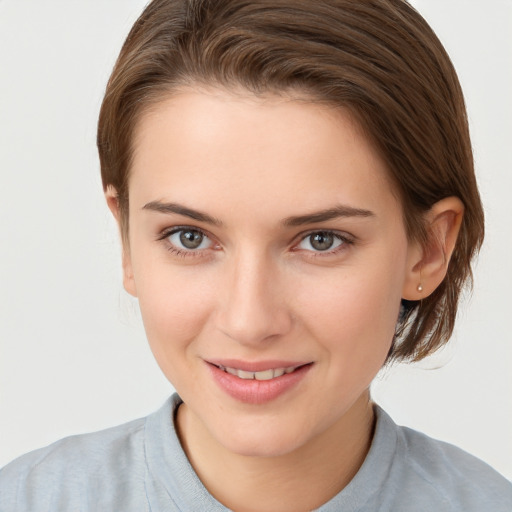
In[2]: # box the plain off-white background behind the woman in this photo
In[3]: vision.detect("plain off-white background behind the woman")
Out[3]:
[0,0,512,479]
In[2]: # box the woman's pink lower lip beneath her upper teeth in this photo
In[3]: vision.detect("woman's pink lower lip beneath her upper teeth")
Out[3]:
[208,363,313,404]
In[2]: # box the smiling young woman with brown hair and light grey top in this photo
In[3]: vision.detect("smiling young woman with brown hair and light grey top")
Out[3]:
[0,0,512,511]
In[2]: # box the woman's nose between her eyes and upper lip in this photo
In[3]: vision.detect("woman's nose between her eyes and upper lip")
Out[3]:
[217,251,292,346]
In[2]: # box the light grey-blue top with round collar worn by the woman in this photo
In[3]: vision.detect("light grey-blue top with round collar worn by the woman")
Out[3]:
[0,395,512,512]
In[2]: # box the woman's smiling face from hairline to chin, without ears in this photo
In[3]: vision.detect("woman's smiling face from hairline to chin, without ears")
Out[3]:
[124,90,416,455]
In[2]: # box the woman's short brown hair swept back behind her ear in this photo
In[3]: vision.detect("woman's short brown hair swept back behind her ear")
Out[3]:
[97,0,484,360]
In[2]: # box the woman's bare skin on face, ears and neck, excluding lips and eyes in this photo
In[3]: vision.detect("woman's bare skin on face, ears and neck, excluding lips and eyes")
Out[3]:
[107,89,463,512]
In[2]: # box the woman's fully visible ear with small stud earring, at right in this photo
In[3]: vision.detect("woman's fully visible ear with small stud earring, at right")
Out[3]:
[402,197,464,300]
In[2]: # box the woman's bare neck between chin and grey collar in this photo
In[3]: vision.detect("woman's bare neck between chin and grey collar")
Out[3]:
[177,392,374,512]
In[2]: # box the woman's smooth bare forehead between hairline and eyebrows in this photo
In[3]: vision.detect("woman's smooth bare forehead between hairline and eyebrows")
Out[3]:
[129,89,395,221]
